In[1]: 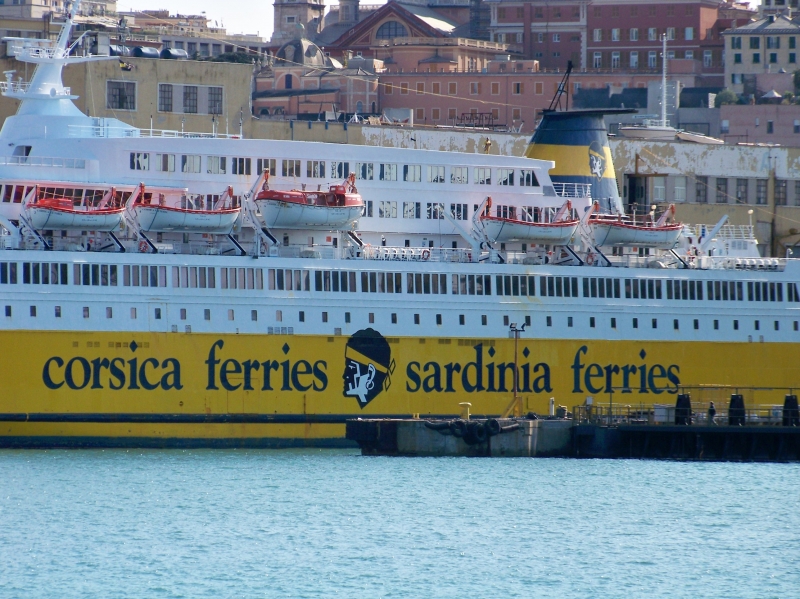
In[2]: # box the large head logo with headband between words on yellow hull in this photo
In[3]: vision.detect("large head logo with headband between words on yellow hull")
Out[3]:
[342,329,395,408]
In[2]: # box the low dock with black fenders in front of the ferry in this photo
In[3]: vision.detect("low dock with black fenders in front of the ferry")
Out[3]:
[346,395,800,462]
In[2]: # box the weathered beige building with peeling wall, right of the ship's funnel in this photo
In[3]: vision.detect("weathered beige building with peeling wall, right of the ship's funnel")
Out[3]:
[610,138,800,256]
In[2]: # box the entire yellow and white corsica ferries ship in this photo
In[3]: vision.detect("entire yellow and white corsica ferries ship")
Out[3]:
[0,3,800,446]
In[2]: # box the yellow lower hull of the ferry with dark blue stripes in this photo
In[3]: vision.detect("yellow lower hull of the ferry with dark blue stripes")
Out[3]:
[0,331,800,446]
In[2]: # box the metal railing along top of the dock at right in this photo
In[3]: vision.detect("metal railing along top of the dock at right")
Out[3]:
[571,404,785,427]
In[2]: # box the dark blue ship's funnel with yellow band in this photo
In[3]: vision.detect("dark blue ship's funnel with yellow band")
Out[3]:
[525,108,636,212]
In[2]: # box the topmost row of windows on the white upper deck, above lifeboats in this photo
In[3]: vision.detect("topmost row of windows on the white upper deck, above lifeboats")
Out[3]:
[130,152,539,187]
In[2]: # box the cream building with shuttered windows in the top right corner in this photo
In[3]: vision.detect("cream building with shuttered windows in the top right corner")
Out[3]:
[723,15,800,96]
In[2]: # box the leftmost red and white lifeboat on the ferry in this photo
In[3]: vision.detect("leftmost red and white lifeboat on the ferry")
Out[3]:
[25,186,125,231]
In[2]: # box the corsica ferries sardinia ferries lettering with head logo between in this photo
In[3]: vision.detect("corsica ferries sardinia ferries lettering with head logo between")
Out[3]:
[42,338,680,398]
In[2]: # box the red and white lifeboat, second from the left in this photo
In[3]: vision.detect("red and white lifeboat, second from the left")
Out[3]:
[133,187,241,235]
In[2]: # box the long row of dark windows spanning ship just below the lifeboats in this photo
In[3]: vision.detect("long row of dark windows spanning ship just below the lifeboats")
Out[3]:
[0,262,800,303]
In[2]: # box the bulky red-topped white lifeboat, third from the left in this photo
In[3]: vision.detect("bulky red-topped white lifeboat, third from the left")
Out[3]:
[255,174,364,231]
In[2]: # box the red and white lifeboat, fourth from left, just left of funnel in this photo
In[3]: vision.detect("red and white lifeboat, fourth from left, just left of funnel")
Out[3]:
[480,198,580,245]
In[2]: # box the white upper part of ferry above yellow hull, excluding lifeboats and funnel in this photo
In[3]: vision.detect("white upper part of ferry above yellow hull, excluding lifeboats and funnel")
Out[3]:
[0,0,800,352]
